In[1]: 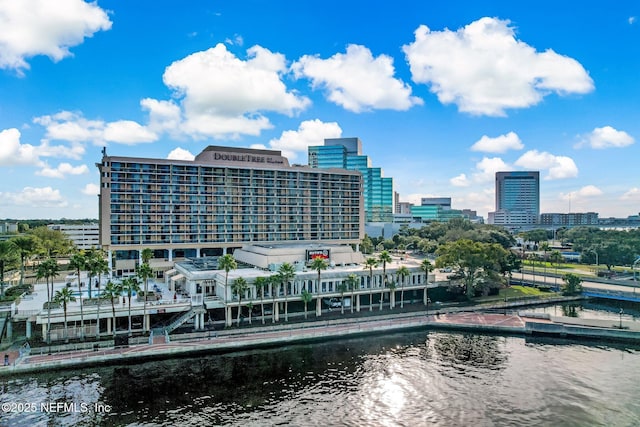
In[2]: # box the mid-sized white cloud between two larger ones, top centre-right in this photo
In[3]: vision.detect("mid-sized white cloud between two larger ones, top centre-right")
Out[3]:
[291,44,423,113]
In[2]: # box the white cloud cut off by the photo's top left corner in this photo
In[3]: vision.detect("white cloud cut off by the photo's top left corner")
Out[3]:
[0,0,111,75]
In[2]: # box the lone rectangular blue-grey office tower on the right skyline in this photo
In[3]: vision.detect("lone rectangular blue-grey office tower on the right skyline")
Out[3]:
[489,171,540,226]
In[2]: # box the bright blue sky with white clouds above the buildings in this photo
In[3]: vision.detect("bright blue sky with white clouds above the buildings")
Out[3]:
[0,0,640,219]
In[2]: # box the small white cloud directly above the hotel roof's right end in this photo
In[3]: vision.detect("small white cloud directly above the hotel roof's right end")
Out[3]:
[269,119,342,159]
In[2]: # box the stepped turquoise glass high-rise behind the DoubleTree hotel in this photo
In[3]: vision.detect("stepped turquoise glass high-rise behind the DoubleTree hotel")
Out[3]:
[309,138,393,223]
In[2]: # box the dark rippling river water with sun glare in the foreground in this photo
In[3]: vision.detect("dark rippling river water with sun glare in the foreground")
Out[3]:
[0,302,640,427]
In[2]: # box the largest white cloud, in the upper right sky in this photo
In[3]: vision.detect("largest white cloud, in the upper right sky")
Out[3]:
[403,17,594,116]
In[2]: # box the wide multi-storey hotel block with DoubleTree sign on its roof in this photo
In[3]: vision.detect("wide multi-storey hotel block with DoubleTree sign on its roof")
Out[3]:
[97,146,364,275]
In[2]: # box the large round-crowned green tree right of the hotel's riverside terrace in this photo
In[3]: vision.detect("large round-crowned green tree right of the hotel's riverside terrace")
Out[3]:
[436,240,507,299]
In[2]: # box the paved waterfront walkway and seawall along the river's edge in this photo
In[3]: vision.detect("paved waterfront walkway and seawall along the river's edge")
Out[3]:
[0,312,640,375]
